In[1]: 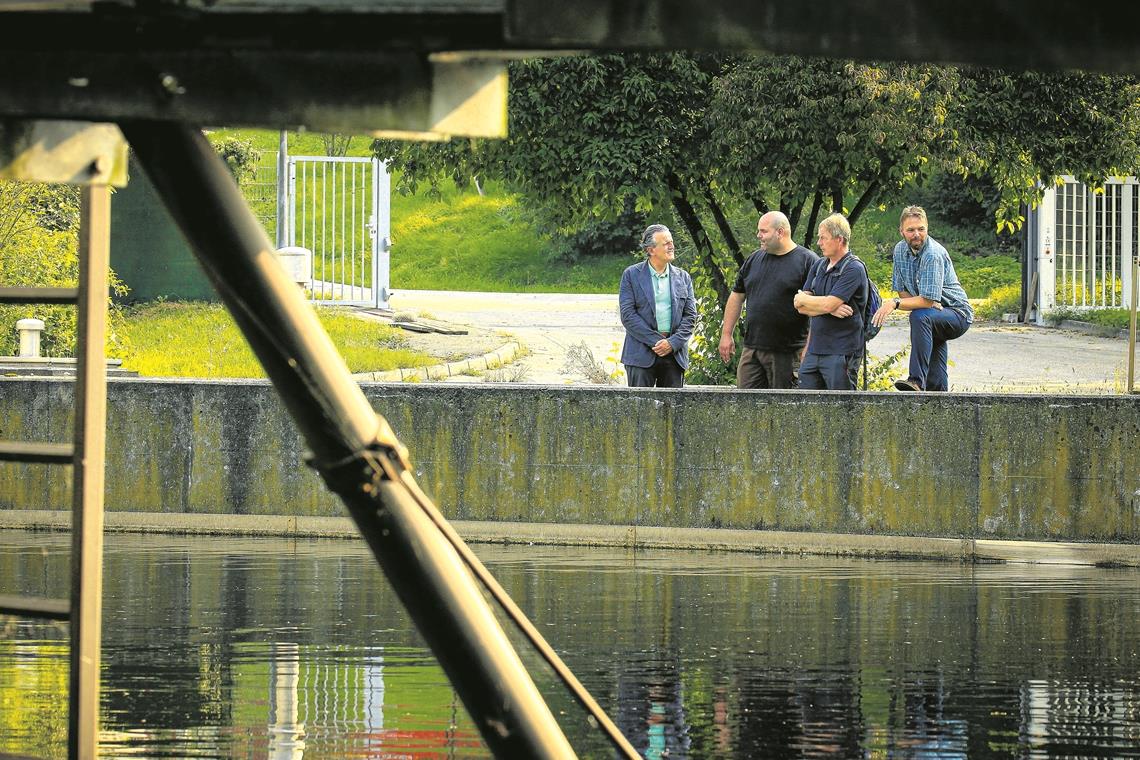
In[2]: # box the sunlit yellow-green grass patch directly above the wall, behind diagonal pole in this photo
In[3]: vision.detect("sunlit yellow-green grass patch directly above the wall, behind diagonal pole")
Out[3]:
[120,302,435,377]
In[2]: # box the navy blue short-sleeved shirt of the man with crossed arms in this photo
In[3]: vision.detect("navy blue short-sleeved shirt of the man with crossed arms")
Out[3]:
[804,252,868,356]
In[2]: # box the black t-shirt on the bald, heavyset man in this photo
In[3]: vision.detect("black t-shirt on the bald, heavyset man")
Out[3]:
[732,245,820,352]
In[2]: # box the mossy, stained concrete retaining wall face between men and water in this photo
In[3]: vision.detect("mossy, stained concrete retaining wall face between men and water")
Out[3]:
[0,378,1140,541]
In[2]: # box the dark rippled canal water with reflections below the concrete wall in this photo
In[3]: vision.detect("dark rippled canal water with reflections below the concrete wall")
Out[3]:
[0,531,1140,759]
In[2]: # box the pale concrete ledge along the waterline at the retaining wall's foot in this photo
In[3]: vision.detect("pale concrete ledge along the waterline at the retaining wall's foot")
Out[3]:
[0,509,1140,567]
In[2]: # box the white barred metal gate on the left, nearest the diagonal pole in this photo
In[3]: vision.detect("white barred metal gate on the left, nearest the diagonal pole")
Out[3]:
[284,156,391,308]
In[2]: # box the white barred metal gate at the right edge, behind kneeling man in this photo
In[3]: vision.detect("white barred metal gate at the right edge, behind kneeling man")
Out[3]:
[1033,177,1140,310]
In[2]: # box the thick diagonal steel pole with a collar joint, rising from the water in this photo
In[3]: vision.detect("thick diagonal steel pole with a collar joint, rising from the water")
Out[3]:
[120,122,575,758]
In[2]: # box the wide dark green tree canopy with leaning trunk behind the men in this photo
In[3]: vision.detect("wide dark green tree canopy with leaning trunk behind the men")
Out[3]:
[374,54,1140,382]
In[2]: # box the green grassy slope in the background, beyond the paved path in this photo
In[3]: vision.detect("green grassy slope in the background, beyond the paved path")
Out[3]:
[211,130,1020,299]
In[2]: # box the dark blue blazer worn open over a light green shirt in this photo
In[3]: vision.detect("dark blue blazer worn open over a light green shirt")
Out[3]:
[618,261,697,369]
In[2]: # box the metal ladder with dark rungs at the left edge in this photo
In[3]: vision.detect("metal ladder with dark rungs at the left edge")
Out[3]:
[0,185,111,759]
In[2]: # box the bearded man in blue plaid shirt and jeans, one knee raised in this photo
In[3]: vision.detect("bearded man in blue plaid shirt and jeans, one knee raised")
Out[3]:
[871,206,974,391]
